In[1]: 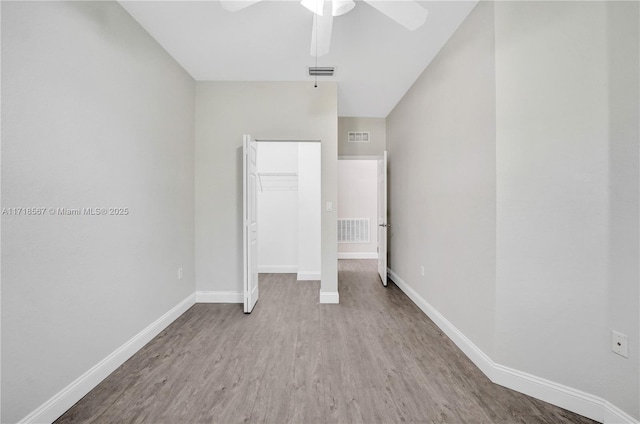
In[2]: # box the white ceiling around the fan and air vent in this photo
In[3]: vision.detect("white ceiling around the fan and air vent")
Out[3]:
[120,0,477,117]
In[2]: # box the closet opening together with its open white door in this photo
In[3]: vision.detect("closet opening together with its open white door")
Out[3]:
[243,135,322,313]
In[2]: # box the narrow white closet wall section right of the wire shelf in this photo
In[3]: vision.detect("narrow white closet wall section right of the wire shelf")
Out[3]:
[298,143,322,280]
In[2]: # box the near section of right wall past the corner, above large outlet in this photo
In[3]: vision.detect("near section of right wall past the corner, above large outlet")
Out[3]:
[495,2,640,418]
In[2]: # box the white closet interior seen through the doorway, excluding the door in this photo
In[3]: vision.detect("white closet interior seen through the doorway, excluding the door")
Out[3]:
[257,140,322,281]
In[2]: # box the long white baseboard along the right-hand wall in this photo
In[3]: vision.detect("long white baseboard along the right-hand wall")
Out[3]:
[388,269,640,424]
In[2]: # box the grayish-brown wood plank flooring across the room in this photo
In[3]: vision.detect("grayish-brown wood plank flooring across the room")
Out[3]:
[56,260,594,424]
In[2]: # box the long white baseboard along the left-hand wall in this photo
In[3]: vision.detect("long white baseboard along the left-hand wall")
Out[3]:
[20,294,196,424]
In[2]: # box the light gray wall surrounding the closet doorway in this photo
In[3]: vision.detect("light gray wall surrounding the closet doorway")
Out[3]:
[195,82,338,298]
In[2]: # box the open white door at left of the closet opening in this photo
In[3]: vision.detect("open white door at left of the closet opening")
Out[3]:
[242,135,259,314]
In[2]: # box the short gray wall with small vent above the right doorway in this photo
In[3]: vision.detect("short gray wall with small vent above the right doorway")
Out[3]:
[338,117,387,156]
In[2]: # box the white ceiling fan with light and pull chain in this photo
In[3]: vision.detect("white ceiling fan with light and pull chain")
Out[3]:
[220,0,429,57]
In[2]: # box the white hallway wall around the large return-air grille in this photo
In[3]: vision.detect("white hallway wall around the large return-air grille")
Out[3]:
[338,159,378,259]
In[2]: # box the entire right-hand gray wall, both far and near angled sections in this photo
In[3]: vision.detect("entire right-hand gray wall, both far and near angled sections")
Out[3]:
[387,2,640,418]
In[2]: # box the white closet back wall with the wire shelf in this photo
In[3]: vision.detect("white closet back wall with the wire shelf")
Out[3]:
[258,143,298,273]
